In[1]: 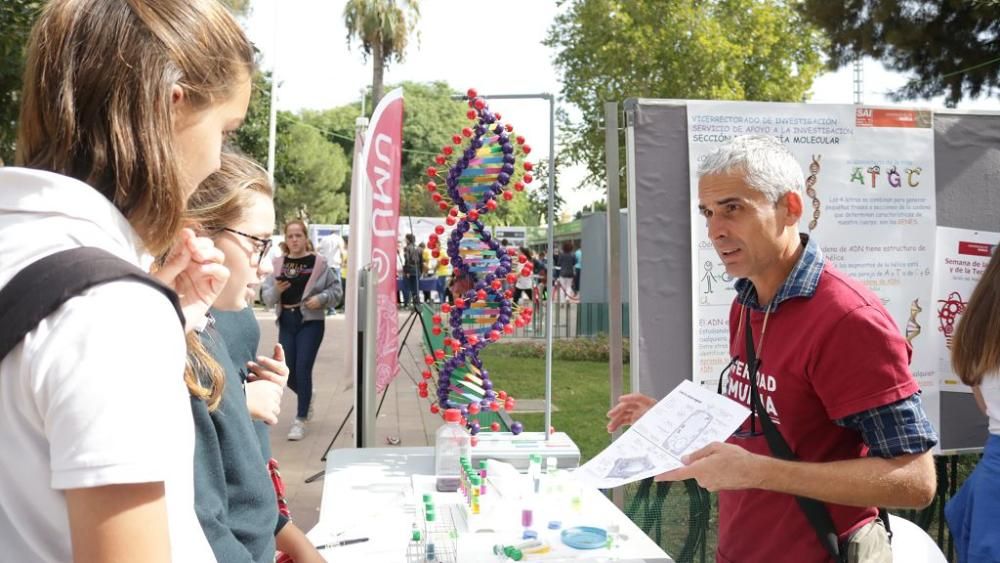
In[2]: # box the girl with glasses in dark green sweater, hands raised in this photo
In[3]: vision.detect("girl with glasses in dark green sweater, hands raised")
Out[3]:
[186,153,322,563]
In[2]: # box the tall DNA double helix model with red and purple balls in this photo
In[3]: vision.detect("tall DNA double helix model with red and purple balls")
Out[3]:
[418,89,533,444]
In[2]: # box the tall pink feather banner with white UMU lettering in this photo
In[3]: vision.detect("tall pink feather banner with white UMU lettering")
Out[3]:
[365,88,403,392]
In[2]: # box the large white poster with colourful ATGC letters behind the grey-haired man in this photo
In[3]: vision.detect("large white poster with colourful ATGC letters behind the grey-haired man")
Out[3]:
[687,101,937,400]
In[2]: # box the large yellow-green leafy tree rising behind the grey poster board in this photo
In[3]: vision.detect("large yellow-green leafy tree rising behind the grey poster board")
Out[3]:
[545,0,823,188]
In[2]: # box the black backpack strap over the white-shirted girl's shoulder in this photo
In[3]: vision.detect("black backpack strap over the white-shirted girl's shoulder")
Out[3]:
[0,247,184,360]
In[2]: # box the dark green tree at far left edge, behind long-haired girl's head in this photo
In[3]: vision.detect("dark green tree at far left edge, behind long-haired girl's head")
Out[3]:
[0,0,42,165]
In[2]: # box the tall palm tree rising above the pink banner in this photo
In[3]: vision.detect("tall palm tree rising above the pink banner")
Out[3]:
[344,0,420,107]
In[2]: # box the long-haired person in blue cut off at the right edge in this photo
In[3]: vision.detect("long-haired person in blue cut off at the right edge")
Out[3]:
[944,250,1000,563]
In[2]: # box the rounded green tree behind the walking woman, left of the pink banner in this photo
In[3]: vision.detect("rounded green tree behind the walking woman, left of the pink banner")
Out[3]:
[274,112,350,223]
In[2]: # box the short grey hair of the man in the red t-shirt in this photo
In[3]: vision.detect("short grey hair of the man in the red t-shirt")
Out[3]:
[698,135,805,203]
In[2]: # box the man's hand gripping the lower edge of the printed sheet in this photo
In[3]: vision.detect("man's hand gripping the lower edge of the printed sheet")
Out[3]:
[655,442,766,492]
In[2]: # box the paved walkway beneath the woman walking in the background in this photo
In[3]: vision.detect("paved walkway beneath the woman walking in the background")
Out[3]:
[257,310,440,531]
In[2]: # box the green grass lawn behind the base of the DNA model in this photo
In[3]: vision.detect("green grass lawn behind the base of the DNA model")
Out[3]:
[480,345,628,463]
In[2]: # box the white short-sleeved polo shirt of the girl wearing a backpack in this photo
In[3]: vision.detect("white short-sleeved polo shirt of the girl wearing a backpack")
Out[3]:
[0,168,214,562]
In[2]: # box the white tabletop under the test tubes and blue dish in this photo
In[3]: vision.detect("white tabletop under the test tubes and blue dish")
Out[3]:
[308,447,673,563]
